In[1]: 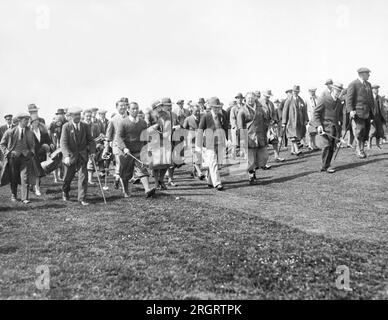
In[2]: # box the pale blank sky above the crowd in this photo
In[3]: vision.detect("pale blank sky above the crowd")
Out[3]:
[0,0,388,121]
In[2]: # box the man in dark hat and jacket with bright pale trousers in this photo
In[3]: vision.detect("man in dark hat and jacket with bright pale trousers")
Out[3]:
[196,97,228,191]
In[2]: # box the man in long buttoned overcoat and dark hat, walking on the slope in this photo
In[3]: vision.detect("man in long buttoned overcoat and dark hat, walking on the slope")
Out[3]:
[282,86,308,156]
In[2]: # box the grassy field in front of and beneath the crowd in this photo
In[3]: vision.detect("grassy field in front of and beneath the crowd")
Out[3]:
[0,145,388,299]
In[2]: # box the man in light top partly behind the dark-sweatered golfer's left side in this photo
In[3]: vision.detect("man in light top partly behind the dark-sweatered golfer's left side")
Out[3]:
[102,98,129,189]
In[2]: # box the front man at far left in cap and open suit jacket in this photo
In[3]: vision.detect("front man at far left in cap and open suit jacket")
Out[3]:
[0,113,35,204]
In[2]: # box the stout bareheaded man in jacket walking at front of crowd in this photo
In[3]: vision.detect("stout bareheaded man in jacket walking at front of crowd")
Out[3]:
[237,92,271,184]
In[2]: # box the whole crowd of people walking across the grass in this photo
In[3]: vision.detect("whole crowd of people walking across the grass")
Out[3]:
[0,68,388,206]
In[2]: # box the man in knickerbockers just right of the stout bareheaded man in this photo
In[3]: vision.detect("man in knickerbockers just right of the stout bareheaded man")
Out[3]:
[259,89,284,164]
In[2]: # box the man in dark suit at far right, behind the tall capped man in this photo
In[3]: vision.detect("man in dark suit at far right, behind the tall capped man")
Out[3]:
[368,85,387,149]
